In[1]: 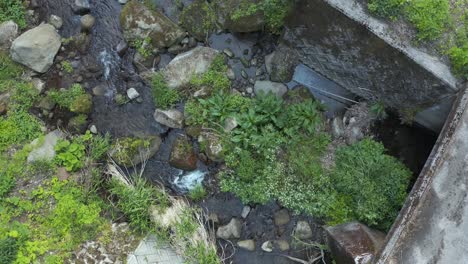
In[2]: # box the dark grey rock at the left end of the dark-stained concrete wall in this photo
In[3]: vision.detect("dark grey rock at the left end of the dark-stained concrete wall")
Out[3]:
[265,45,299,82]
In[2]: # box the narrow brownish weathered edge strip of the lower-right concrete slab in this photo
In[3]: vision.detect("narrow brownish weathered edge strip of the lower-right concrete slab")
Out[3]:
[373,86,468,264]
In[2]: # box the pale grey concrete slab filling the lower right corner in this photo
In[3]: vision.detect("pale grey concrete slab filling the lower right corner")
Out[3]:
[375,85,468,264]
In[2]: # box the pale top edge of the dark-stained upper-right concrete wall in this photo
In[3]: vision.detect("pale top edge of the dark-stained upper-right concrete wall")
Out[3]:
[324,0,459,91]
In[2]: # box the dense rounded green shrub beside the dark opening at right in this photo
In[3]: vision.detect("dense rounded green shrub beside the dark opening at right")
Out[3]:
[332,139,411,230]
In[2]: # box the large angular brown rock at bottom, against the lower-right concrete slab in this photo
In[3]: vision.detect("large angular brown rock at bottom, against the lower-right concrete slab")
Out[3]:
[326,222,385,264]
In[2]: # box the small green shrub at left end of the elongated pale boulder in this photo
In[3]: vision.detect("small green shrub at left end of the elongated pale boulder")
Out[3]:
[151,73,180,109]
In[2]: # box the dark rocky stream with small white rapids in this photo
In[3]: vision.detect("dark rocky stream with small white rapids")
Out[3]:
[35,0,436,264]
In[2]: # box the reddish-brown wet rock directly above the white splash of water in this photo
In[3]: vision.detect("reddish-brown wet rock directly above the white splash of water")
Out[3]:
[169,136,197,171]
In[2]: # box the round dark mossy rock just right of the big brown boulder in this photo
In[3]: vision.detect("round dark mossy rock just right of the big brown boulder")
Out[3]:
[180,0,217,41]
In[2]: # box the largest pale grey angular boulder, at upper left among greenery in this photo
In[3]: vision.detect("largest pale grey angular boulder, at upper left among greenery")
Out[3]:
[10,24,62,73]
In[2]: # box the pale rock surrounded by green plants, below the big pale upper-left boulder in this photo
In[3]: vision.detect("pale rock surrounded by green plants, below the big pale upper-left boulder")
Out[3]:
[28,130,64,162]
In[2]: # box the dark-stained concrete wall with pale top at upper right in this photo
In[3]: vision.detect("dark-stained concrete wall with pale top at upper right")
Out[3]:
[282,0,459,131]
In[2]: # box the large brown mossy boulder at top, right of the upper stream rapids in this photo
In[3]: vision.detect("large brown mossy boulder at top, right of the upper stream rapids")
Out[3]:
[120,1,185,48]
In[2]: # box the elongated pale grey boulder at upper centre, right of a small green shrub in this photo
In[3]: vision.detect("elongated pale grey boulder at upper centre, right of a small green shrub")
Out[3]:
[163,47,219,89]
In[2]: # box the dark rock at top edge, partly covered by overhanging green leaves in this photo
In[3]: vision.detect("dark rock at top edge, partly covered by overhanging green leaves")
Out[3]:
[216,0,265,32]
